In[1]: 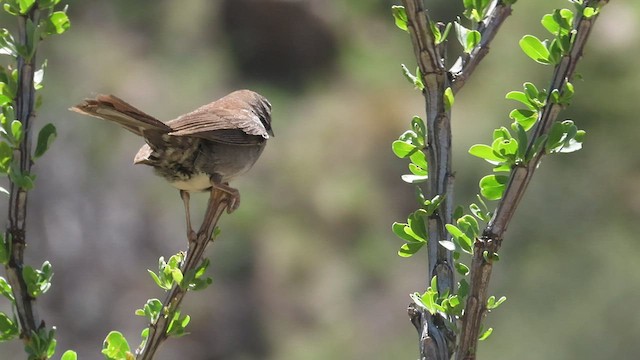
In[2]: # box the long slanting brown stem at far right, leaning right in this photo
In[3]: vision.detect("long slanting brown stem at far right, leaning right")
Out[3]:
[456,0,608,360]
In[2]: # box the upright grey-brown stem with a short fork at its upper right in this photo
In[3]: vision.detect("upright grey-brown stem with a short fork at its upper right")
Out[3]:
[403,0,511,359]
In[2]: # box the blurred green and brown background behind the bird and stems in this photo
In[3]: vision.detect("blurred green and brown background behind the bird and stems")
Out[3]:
[0,0,640,360]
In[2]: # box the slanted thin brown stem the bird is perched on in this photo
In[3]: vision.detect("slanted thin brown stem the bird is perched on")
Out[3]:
[136,188,229,360]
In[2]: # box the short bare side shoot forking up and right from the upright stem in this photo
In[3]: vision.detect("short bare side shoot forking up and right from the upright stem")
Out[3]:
[449,0,511,93]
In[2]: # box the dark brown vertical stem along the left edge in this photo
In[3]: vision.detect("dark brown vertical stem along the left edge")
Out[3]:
[6,4,44,343]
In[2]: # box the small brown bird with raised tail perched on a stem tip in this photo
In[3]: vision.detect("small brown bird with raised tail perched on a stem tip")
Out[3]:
[70,90,273,234]
